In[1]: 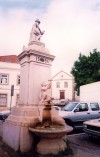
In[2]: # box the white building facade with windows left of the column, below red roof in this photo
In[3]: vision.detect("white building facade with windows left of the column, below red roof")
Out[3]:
[0,61,20,108]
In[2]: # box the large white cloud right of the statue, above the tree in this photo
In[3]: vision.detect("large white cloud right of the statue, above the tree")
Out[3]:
[42,0,100,72]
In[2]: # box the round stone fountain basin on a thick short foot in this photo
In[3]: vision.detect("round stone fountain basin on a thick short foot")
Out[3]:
[29,124,73,155]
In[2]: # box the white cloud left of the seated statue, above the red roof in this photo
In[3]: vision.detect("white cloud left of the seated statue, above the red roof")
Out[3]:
[0,9,40,55]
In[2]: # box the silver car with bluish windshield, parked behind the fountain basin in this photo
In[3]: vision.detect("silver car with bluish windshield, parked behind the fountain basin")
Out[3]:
[59,102,100,129]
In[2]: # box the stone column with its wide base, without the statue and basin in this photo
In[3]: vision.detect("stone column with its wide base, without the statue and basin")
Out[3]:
[3,41,54,152]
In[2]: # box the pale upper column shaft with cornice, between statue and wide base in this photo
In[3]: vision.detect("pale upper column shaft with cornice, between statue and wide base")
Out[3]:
[19,41,54,105]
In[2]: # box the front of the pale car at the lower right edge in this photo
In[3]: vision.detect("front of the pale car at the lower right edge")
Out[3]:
[83,118,100,138]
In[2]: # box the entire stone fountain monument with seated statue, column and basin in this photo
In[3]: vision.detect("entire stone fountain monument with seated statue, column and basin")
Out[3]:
[3,19,72,154]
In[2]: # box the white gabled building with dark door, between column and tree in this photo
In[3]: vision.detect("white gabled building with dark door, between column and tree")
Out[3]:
[51,70,75,100]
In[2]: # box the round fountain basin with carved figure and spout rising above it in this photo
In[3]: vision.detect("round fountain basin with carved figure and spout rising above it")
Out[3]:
[29,82,73,155]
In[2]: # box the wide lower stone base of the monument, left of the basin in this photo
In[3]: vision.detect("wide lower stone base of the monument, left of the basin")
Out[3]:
[3,106,39,152]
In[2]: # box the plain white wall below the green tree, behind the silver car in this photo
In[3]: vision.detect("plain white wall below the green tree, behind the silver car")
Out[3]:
[80,81,100,102]
